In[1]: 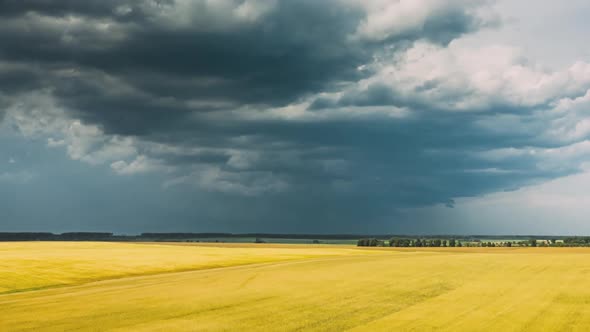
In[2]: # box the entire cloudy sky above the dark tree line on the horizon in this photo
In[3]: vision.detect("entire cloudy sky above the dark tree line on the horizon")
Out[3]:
[0,0,590,235]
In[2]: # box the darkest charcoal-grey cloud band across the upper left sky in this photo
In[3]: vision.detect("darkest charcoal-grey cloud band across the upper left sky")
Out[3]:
[0,1,371,107]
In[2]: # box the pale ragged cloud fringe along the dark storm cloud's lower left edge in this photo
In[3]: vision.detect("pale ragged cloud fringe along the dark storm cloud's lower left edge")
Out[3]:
[0,93,288,196]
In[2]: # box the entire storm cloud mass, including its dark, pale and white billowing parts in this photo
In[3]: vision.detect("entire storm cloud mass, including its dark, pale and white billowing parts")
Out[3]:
[0,0,590,232]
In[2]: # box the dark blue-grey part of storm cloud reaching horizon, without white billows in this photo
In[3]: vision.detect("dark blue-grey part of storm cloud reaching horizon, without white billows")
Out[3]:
[0,0,584,232]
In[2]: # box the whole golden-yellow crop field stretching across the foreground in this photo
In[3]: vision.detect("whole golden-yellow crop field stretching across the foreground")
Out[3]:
[0,242,590,331]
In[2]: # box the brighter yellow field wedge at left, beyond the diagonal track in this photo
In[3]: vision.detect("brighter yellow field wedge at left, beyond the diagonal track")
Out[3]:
[0,242,374,294]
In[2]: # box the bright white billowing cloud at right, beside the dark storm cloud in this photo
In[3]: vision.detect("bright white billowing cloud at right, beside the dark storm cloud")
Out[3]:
[356,41,590,111]
